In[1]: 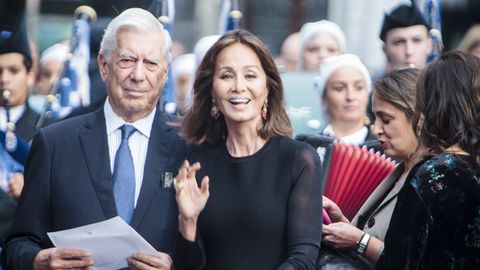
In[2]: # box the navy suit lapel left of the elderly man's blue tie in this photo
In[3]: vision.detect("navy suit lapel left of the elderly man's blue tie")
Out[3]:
[79,109,117,219]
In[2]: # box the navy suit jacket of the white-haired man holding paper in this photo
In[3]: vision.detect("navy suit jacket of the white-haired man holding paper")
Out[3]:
[2,108,187,269]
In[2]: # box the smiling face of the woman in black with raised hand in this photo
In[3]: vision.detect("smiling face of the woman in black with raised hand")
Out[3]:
[212,43,268,130]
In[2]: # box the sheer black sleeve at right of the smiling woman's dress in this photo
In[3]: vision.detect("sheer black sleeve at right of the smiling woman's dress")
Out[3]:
[279,145,323,269]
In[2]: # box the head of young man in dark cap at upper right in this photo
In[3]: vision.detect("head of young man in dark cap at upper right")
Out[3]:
[380,1,432,72]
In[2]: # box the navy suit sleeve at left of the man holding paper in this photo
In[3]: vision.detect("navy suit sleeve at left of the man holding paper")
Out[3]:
[1,131,51,269]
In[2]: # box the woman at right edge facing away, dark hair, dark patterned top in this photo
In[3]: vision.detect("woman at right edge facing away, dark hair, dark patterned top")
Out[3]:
[377,51,480,269]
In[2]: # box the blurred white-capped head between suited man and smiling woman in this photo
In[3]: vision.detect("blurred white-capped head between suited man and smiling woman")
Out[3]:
[172,53,196,115]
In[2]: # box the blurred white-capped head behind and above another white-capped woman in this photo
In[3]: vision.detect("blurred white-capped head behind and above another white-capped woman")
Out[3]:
[299,20,347,71]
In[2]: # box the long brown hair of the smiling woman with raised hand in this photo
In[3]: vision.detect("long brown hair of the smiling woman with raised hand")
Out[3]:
[181,30,292,144]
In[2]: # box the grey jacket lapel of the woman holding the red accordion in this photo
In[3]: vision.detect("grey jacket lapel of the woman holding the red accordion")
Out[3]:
[352,163,405,225]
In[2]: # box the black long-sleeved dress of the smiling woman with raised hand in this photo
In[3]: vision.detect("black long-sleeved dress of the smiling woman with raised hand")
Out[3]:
[173,137,323,270]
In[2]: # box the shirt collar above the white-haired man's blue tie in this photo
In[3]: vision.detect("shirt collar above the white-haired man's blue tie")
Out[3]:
[103,97,157,138]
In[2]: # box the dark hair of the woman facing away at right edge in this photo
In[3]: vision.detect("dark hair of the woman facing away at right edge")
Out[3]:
[413,50,480,162]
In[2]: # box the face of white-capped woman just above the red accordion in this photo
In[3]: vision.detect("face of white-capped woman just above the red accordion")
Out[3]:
[322,66,368,124]
